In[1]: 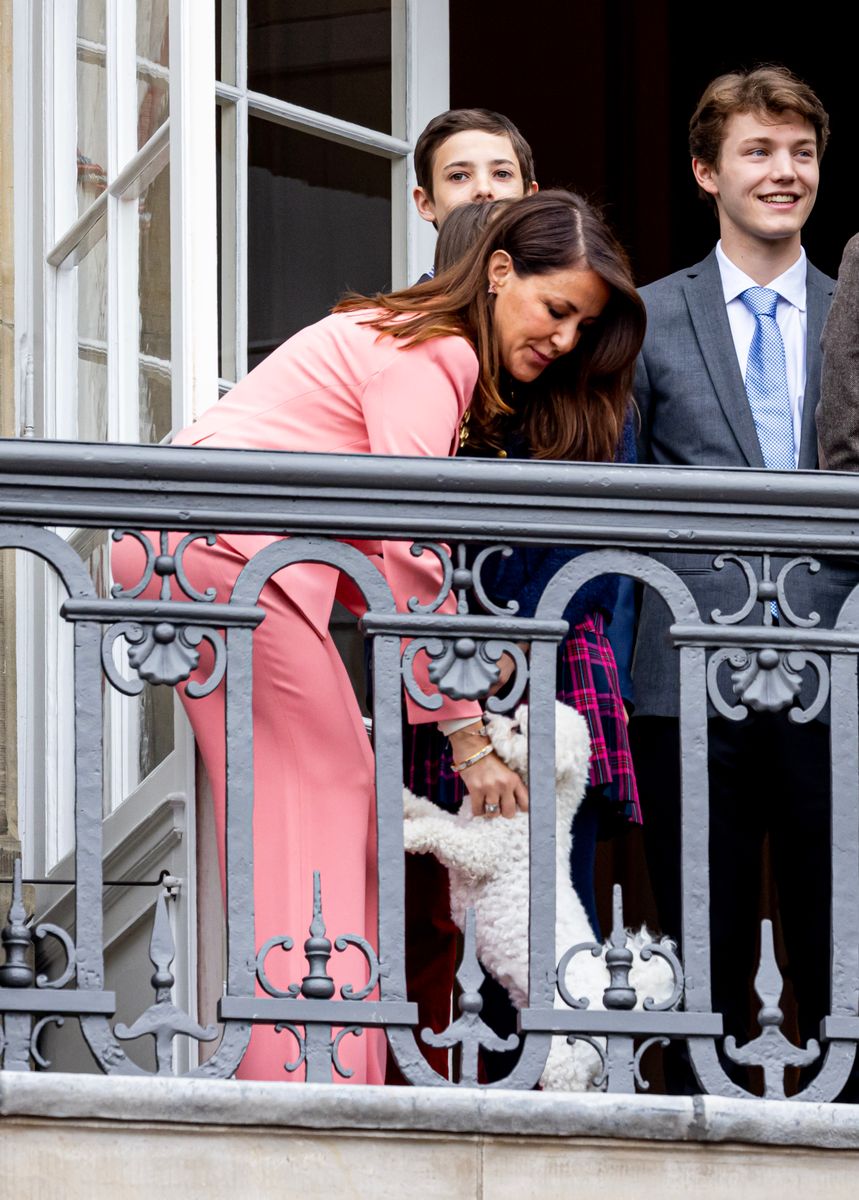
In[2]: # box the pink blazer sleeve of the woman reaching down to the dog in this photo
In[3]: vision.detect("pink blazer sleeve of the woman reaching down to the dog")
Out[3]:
[362,337,481,725]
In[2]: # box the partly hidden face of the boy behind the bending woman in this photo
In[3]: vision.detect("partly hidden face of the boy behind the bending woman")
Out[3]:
[414,130,536,224]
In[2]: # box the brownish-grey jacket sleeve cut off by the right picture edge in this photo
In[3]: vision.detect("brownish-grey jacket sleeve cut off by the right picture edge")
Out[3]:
[817,234,859,470]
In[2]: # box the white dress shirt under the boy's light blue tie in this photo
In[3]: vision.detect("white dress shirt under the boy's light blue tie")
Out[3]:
[716,241,807,462]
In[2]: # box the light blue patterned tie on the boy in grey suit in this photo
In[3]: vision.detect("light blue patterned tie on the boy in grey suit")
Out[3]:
[740,288,797,470]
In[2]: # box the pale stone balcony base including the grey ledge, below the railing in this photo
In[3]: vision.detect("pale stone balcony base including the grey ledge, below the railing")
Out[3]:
[0,1073,859,1200]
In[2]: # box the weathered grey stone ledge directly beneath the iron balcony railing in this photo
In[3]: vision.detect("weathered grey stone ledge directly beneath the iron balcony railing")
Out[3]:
[0,1072,859,1150]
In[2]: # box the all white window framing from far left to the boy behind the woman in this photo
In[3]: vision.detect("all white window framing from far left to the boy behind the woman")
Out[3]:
[13,0,449,1068]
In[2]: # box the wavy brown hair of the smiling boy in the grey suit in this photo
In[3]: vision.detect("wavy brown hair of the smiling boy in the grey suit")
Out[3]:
[689,65,829,168]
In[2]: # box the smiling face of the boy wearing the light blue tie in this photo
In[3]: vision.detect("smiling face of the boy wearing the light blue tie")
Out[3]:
[692,112,819,250]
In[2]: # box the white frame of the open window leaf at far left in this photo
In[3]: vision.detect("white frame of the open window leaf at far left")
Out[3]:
[13,0,217,1068]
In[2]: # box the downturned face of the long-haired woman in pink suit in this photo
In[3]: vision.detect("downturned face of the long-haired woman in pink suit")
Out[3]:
[488,250,609,383]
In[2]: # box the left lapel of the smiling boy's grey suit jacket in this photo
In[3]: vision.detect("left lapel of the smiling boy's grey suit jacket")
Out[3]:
[683,251,763,467]
